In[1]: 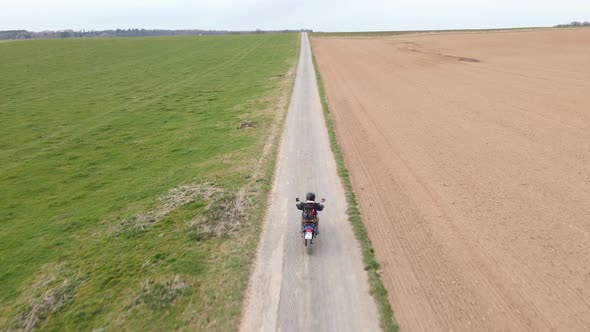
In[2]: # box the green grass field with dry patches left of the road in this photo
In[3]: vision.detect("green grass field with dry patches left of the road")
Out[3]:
[0,34,299,331]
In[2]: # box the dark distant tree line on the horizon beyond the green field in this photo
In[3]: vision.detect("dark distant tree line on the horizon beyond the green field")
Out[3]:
[0,29,312,40]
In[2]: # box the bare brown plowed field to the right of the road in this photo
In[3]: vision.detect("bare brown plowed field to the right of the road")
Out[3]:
[313,29,590,331]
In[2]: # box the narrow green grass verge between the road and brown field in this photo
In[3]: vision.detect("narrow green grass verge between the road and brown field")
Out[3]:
[310,44,399,332]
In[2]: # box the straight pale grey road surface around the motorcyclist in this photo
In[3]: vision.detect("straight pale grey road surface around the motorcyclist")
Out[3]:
[241,34,379,331]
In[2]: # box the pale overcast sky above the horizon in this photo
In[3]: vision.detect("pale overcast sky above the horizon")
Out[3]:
[0,0,590,31]
